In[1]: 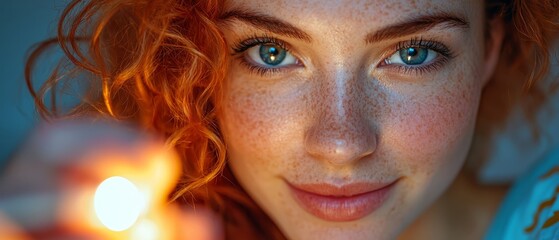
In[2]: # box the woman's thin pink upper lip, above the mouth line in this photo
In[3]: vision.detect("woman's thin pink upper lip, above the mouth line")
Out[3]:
[289,181,395,197]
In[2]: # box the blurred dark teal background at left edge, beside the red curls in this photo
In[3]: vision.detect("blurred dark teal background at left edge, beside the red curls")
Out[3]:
[0,0,68,163]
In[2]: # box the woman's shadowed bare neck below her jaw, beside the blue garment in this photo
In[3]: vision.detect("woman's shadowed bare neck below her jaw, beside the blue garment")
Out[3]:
[400,172,508,240]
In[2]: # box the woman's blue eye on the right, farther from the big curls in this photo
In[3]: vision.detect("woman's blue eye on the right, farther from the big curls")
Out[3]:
[385,47,438,66]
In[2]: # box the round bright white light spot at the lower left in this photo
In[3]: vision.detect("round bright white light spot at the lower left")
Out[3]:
[93,176,146,232]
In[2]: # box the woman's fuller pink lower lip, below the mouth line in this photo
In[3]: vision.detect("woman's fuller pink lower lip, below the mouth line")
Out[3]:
[290,183,394,222]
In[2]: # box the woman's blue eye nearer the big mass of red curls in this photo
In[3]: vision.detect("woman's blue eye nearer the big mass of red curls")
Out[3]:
[245,43,297,68]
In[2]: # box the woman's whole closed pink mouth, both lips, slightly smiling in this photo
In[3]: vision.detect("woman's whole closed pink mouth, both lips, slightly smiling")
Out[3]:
[288,181,397,222]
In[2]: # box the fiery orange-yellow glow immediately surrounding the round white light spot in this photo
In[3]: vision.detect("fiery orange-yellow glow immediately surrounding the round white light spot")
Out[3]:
[53,143,180,239]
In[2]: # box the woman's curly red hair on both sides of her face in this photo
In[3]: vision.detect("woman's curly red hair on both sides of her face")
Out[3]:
[25,0,559,239]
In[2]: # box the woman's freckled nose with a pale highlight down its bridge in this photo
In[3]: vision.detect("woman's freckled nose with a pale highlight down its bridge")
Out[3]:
[305,68,377,165]
